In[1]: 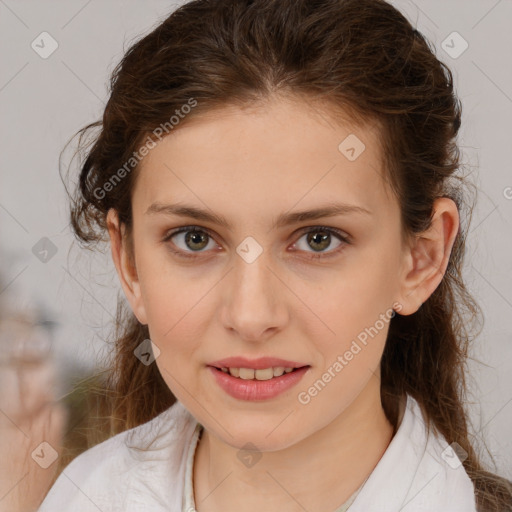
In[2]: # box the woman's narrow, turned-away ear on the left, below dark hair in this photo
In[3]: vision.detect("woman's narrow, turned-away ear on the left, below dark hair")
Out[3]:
[107,208,147,325]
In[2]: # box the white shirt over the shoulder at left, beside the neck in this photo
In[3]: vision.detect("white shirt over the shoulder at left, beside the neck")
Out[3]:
[39,402,197,512]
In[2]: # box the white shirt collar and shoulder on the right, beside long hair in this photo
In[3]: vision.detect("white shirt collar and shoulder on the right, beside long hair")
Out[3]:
[351,395,476,512]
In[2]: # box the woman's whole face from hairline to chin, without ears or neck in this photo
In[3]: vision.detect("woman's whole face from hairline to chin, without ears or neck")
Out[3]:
[115,95,405,451]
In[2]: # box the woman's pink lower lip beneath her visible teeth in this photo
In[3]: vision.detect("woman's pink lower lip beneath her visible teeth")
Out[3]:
[208,366,310,401]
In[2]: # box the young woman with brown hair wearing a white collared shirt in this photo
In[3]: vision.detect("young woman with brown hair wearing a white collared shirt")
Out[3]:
[40,0,512,512]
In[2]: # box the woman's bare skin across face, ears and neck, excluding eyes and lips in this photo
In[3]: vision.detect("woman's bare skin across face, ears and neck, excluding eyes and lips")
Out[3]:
[107,93,459,512]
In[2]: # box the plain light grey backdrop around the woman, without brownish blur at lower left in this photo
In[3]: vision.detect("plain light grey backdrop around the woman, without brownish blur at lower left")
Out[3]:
[0,0,512,478]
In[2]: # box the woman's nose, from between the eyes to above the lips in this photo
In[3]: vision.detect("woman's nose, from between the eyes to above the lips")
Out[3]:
[221,246,290,342]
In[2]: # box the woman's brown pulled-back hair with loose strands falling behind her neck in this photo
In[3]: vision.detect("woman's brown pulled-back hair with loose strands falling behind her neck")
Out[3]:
[63,0,512,512]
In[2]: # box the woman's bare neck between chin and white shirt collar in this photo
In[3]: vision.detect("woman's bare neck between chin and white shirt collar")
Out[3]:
[193,379,393,512]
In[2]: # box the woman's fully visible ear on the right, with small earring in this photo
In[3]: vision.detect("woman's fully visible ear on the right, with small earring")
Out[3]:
[397,197,459,315]
